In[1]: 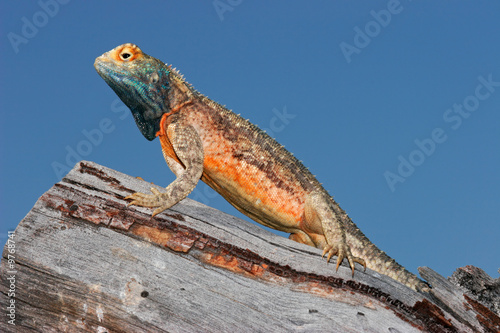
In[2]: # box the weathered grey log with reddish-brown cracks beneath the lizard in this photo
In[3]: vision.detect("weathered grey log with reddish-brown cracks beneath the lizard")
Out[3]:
[0,162,500,332]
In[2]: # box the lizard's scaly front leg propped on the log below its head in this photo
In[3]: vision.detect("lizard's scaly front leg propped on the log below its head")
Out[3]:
[125,123,203,216]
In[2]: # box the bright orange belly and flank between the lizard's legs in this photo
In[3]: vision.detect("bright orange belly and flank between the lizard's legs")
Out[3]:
[202,150,305,232]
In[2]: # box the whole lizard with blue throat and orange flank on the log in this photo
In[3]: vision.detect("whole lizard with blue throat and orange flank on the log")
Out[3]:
[94,44,427,290]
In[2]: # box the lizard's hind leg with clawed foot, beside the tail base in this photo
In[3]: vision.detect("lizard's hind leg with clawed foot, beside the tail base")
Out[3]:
[304,192,366,276]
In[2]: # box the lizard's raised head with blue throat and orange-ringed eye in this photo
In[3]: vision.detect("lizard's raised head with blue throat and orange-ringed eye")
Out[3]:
[94,44,170,140]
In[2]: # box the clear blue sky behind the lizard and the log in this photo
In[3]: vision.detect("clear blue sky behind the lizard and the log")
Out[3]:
[0,0,500,277]
